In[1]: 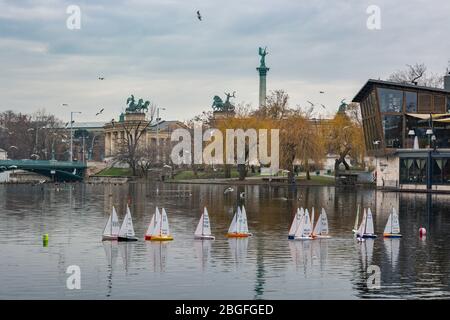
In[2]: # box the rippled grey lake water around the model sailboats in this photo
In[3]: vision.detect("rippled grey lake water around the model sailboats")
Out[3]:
[0,183,450,299]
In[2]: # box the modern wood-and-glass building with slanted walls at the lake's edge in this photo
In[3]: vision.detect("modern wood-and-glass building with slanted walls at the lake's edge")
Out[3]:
[353,78,450,191]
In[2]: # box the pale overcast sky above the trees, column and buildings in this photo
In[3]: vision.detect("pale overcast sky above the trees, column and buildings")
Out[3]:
[0,0,450,121]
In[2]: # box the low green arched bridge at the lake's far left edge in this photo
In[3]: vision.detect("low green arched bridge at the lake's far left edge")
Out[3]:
[0,160,87,181]
